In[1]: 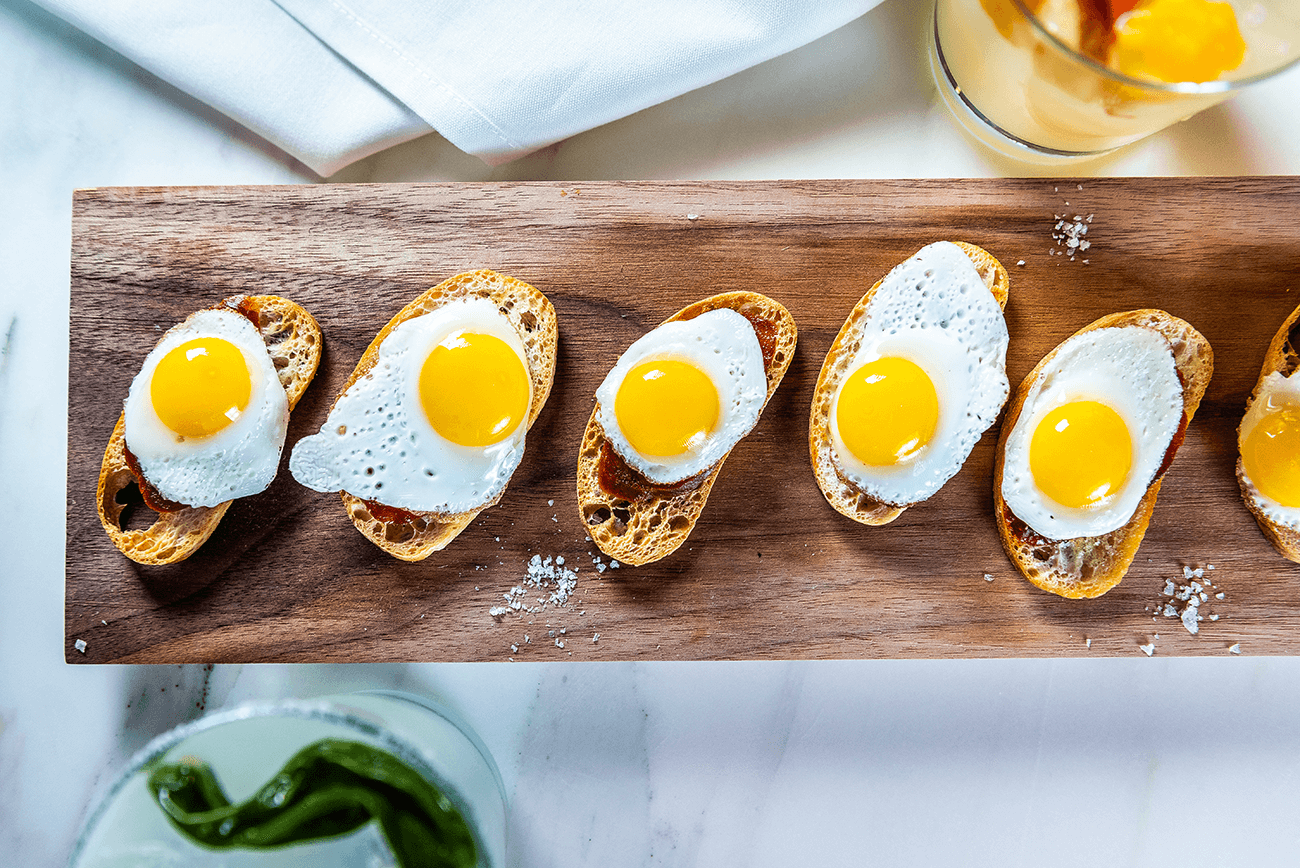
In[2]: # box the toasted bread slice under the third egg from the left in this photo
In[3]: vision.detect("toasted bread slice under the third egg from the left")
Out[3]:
[577,292,798,565]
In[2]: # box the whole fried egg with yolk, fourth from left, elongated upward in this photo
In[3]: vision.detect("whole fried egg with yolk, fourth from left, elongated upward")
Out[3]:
[829,242,1010,505]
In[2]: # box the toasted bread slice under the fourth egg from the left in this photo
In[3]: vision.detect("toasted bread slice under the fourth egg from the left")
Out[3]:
[809,242,1010,526]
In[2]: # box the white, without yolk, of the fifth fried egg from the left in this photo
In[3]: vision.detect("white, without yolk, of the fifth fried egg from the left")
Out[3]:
[1002,326,1183,539]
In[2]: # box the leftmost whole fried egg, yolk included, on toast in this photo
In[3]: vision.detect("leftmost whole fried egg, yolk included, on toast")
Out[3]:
[124,308,289,507]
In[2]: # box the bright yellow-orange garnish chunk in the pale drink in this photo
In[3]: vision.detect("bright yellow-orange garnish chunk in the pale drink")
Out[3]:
[1114,0,1245,82]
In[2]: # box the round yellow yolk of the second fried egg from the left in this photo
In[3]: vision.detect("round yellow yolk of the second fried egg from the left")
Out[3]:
[420,331,529,447]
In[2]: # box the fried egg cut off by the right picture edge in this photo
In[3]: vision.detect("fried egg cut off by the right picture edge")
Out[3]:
[1238,372,1300,530]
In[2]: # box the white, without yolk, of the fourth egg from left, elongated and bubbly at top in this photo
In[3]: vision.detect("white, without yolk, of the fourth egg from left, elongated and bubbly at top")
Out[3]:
[829,242,1010,505]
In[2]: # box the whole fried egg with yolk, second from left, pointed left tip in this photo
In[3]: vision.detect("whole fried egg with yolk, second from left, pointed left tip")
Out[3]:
[289,298,533,515]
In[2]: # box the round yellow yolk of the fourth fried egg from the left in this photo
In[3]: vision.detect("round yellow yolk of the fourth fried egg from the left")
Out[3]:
[836,356,939,466]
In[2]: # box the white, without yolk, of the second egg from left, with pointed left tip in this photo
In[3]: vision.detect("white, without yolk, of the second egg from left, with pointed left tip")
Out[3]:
[289,298,533,515]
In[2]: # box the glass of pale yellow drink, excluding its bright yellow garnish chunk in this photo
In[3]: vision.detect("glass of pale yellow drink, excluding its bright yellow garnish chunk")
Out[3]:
[930,0,1300,164]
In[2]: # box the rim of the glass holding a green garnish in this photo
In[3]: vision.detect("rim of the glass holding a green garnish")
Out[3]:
[68,690,506,868]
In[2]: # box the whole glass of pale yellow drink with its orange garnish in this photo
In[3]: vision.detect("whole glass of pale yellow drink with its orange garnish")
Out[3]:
[930,0,1300,164]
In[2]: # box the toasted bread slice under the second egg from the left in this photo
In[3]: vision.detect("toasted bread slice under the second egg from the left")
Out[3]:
[334,269,559,561]
